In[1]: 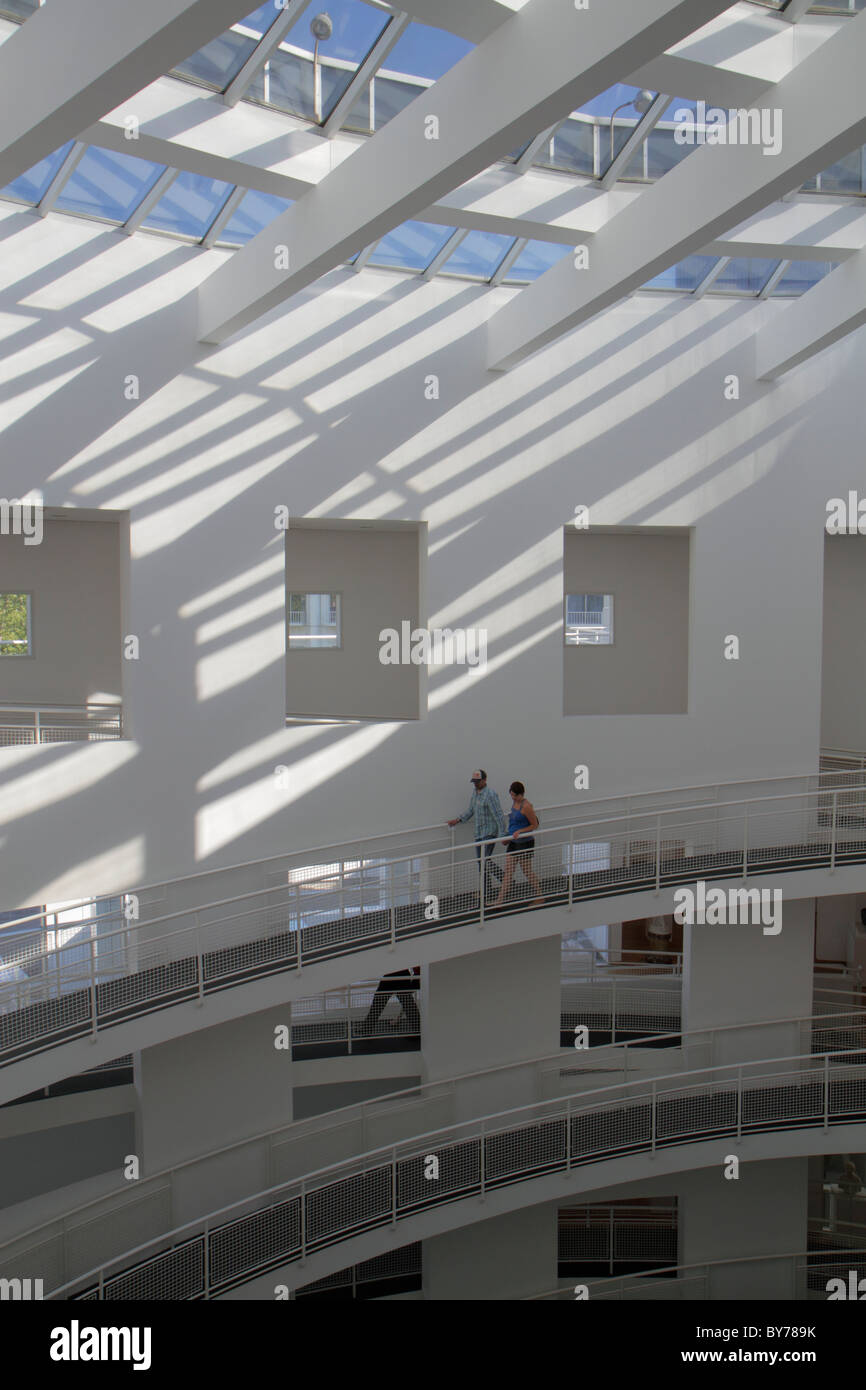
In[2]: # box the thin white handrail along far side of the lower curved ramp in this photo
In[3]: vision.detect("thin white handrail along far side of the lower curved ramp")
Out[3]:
[0,1008,866,1255]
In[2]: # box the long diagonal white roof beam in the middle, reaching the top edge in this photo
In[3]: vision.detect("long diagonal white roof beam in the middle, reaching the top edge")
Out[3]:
[199,0,727,342]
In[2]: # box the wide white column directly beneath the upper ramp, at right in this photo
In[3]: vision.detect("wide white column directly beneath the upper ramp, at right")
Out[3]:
[683,898,815,1063]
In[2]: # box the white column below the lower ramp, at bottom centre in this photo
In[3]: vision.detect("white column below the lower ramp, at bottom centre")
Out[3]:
[424,1202,557,1302]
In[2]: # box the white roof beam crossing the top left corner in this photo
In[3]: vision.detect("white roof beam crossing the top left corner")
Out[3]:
[0,0,261,188]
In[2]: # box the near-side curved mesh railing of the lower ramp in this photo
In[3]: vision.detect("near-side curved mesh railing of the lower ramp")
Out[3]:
[45,1054,866,1300]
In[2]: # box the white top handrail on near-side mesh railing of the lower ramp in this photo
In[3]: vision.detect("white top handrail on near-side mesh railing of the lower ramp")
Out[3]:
[50,1048,863,1298]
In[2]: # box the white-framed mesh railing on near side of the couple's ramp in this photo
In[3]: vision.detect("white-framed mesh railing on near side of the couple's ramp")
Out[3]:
[0,787,866,1065]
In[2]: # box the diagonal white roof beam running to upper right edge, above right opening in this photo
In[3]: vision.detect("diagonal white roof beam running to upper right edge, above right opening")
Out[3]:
[488,17,866,368]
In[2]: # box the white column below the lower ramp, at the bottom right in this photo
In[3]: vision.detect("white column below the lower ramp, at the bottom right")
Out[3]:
[677,1158,809,1295]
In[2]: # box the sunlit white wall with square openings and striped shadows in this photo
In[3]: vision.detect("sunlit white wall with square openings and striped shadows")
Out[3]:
[0,201,866,908]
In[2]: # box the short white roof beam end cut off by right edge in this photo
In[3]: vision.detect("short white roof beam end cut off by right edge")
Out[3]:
[755,252,866,381]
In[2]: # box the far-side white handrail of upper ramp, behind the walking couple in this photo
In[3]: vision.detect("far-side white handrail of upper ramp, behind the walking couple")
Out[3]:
[0,761,866,931]
